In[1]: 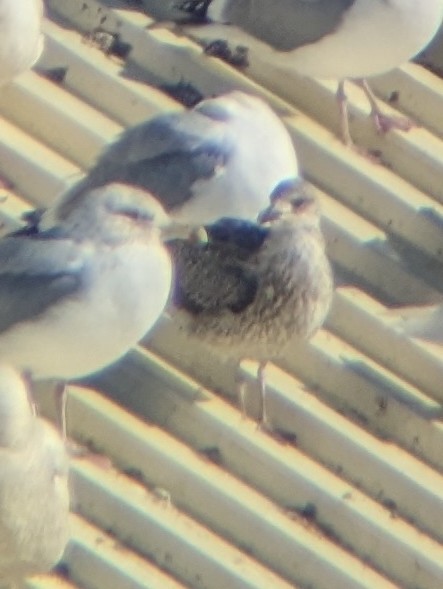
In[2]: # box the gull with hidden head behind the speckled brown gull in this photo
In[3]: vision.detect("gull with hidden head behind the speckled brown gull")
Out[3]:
[34,91,298,228]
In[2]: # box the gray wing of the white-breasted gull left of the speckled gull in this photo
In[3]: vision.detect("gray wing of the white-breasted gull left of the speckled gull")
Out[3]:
[0,237,86,333]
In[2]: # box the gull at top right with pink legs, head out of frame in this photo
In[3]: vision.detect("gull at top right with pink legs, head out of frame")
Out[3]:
[179,0,443,145]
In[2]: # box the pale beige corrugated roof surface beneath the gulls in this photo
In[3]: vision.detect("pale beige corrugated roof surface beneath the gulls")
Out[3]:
[0,0,443,589]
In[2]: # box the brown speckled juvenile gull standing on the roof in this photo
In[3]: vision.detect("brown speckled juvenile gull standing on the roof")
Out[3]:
[168,183,333,426]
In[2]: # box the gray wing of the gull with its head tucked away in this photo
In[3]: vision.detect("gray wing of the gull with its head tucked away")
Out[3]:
[60,111,231,217]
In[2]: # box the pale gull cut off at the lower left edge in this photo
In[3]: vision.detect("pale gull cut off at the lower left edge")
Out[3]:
[0,364,70,587]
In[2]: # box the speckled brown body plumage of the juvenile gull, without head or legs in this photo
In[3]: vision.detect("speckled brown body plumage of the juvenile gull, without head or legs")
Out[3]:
[172,209,333,360]
